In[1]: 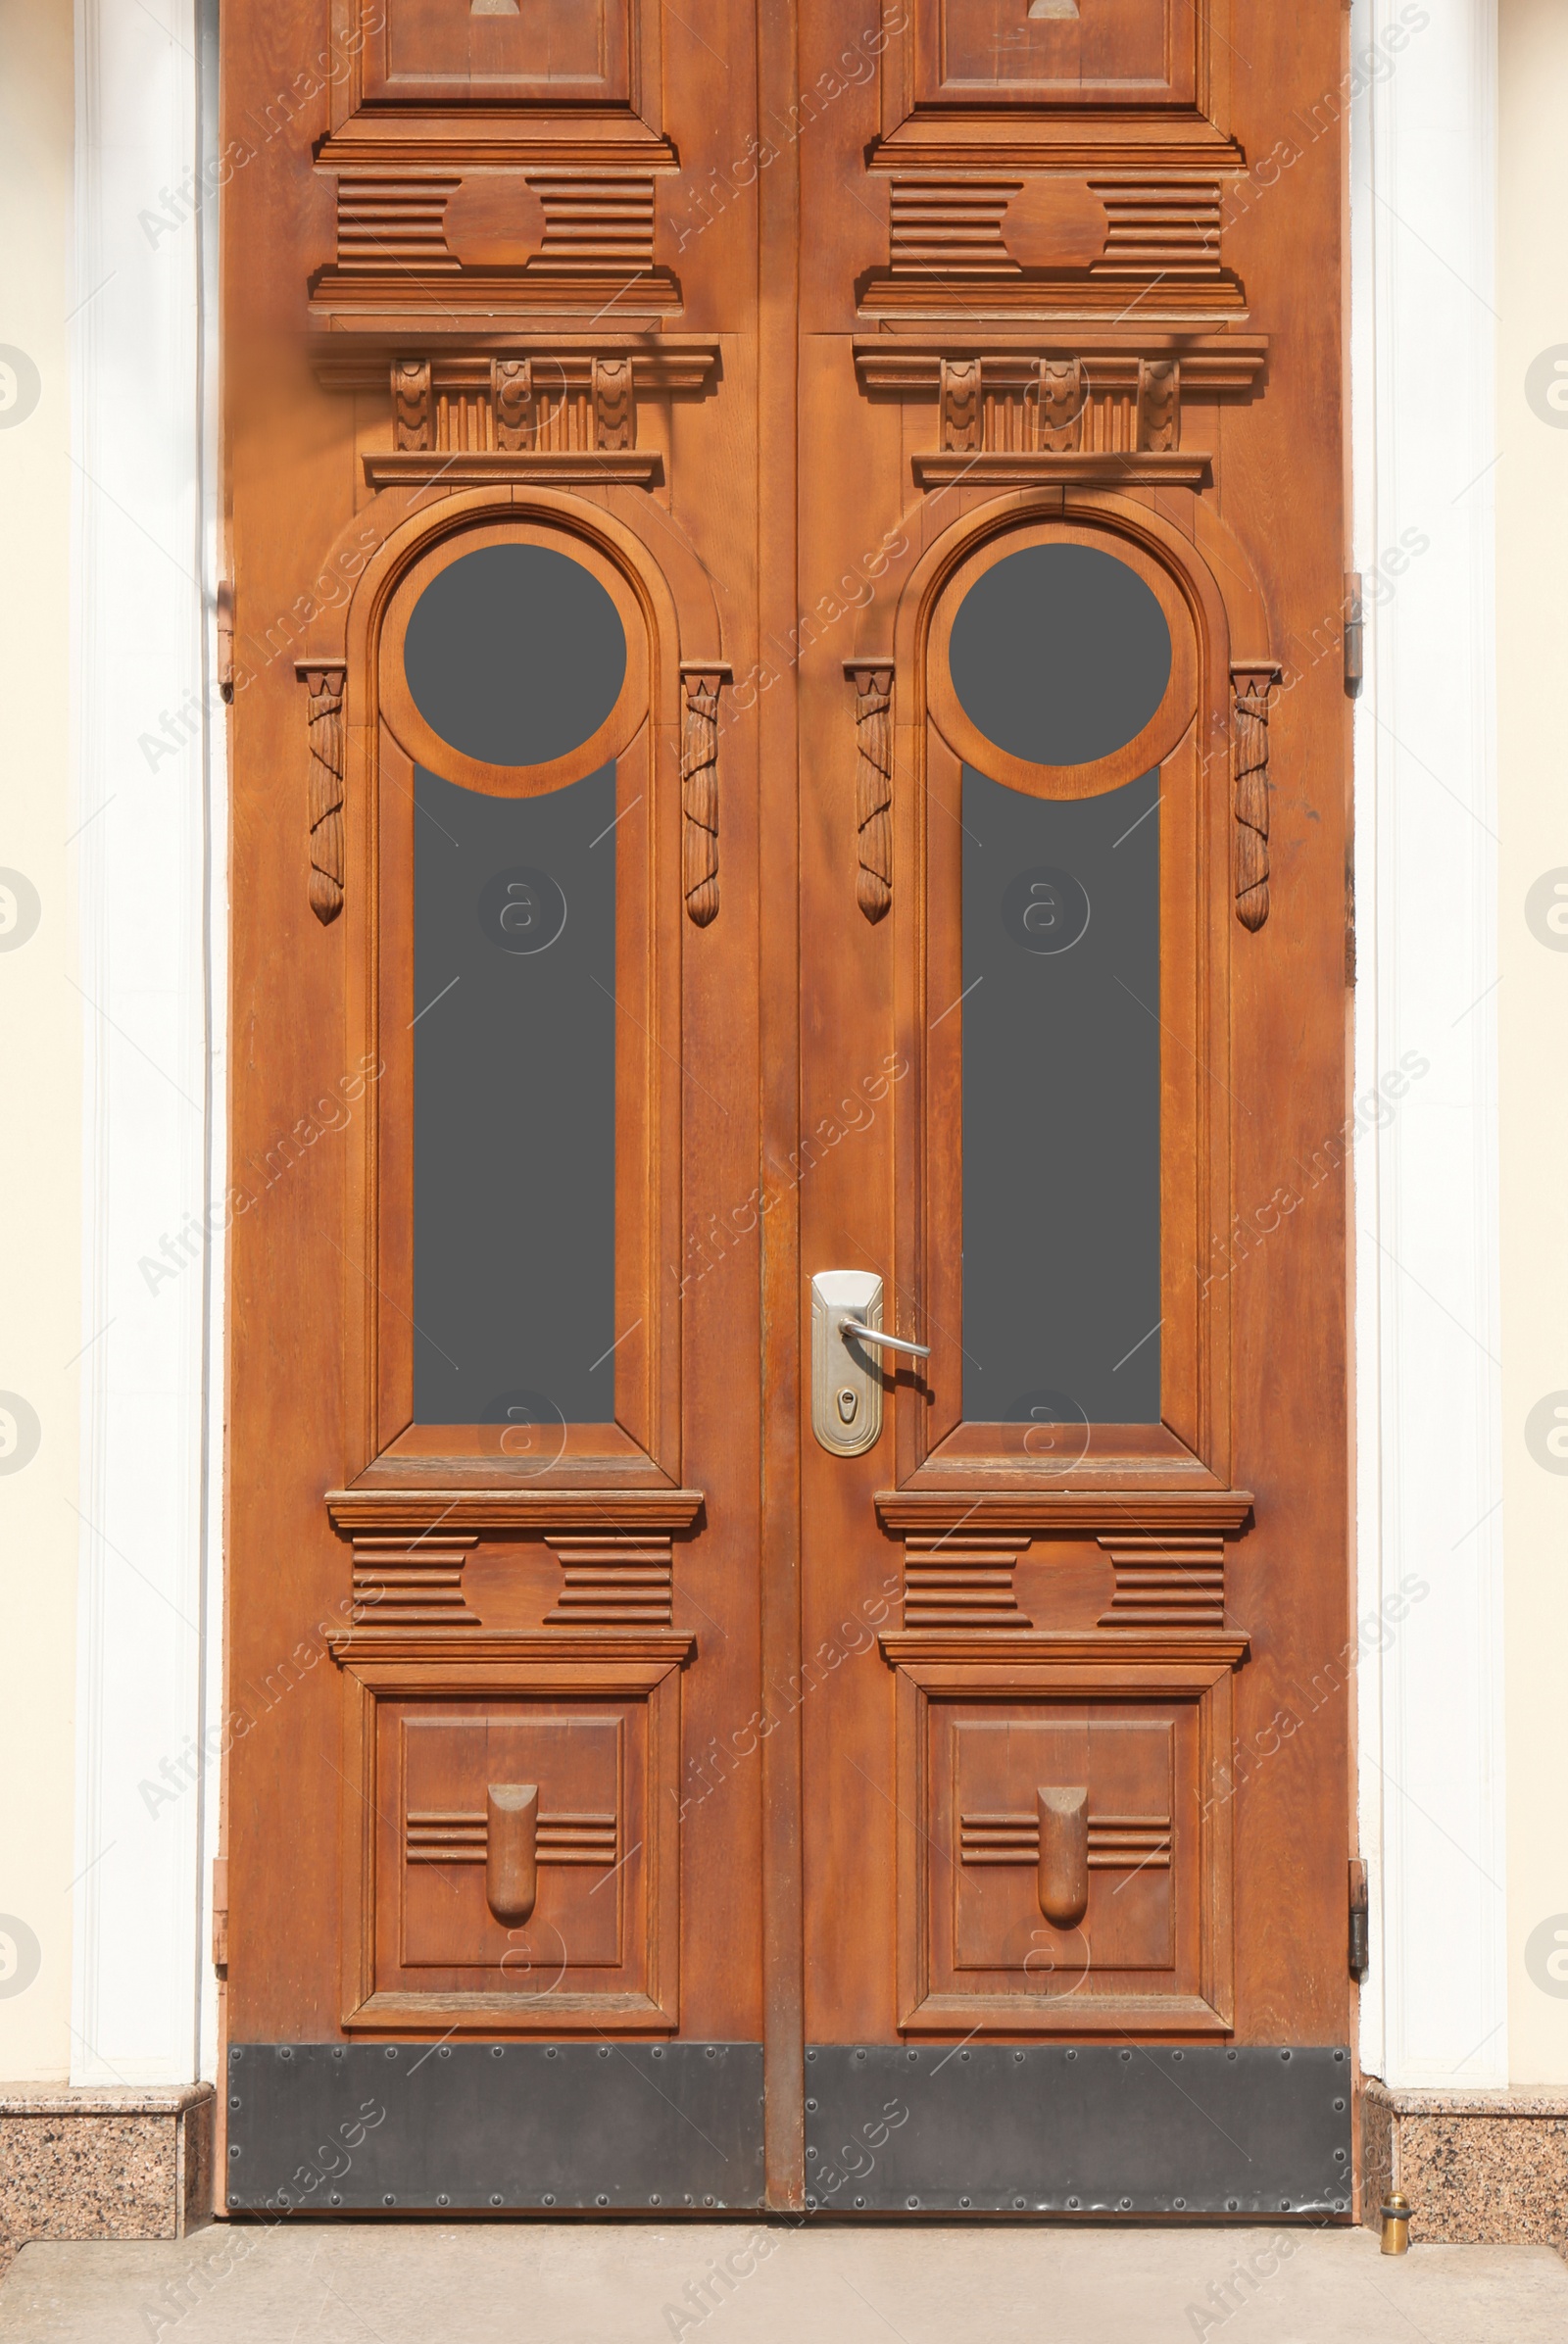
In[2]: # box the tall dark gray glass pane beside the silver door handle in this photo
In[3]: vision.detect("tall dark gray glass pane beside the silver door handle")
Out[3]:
[961,766,1160,1425]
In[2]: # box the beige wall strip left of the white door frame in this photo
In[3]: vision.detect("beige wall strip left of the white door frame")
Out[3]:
[0,0,84,2081]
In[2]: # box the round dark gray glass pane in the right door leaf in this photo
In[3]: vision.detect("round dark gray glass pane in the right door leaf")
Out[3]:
[947,544,1169,764]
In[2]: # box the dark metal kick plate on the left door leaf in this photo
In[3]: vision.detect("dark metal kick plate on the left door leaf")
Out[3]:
[227,2041,764,2213]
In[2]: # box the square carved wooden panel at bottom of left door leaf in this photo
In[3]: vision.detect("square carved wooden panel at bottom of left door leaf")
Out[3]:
[335,1629,689,2032]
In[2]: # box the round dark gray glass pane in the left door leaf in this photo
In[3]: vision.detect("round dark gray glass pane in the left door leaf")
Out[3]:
[403,546,626,764]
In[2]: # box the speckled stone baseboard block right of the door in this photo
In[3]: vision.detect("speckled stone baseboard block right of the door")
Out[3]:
[1362,2081,1568,2255]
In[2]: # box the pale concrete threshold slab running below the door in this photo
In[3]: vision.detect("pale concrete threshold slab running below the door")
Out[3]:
[0,2222,1568,2344]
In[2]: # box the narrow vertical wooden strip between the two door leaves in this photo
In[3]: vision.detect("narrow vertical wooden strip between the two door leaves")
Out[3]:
[755,0,807,2211]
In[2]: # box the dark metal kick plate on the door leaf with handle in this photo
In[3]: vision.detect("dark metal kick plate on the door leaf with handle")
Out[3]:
[807,2044,1350,2215]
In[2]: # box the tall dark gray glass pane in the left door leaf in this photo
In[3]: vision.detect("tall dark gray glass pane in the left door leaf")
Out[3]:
[413,764,616,1425]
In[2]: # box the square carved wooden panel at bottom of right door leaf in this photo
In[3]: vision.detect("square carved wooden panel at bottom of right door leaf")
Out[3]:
[888,1636,1231,2032]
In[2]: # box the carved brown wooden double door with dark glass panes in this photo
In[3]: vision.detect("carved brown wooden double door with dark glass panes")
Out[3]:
[216,0,1354,2215]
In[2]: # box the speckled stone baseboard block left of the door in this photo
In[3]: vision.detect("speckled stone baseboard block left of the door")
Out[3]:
[0,2083,216,2271]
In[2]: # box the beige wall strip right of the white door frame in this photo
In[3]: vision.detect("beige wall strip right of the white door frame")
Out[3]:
[1499,0,1568,2083]
